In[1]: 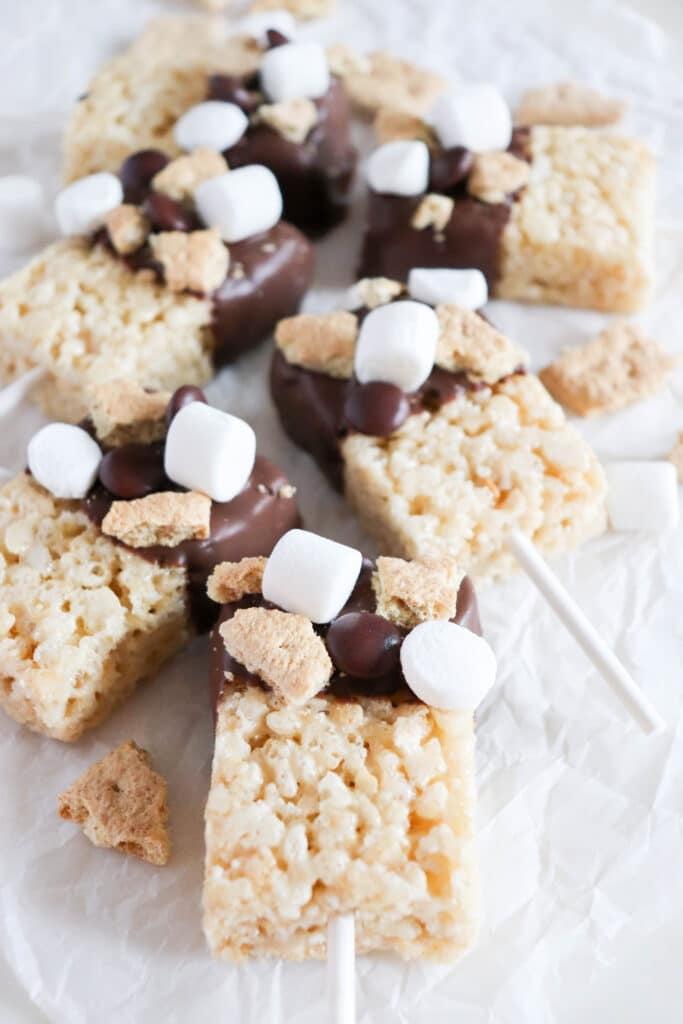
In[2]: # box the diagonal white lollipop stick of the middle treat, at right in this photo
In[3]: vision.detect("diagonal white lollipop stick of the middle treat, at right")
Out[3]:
[508,529,666,733]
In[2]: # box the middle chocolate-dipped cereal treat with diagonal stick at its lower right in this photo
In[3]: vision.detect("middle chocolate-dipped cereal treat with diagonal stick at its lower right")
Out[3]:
[271,270,605,578]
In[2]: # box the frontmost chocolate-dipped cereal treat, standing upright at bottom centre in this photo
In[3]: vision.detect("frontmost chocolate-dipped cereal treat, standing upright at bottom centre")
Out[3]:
[204,530,496,962]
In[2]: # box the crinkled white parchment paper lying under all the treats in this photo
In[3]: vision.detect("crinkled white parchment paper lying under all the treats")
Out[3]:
[0,0,683,1024]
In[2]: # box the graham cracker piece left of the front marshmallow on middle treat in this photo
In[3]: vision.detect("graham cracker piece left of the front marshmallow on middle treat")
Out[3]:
[275,311,358,377]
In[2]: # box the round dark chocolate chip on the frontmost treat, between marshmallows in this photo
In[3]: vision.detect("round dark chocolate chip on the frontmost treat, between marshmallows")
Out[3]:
[326,611,402,679]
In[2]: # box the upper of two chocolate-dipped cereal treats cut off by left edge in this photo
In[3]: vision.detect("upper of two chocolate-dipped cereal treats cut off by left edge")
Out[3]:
[0,148,313,422]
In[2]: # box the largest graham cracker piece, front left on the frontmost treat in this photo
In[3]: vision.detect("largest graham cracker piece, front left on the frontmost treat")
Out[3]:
[220,608,333,705]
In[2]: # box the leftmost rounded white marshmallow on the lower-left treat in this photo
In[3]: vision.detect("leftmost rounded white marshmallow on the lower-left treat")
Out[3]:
[28,423,102,499]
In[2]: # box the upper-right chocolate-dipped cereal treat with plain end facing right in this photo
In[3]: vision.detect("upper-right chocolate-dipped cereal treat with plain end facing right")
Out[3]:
[359,86,654,312]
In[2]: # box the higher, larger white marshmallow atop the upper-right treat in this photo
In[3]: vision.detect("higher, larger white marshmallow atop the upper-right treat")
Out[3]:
[431,82,512,153]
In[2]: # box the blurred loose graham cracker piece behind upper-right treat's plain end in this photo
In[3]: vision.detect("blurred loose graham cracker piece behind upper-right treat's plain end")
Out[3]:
[515,82,626,127]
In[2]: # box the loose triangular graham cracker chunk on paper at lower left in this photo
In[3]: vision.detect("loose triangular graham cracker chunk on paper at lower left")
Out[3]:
[59,740,171,865]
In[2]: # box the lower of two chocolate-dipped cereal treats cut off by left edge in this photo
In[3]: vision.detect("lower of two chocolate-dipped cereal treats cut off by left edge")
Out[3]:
[0,381,298,740]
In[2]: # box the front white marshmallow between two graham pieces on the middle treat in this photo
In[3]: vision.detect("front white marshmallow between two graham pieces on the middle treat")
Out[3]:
[354,301,439,391]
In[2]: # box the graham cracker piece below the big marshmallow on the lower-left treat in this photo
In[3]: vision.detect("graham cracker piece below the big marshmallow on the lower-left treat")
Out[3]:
[101,490,211,548]
